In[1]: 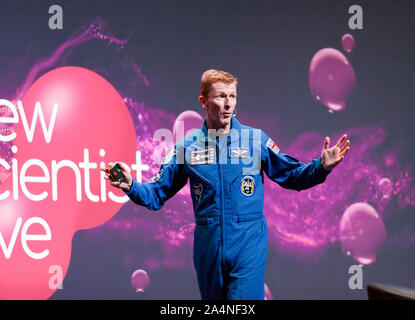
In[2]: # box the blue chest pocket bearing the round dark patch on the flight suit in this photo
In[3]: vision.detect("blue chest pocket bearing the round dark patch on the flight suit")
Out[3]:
[229,170,264,216]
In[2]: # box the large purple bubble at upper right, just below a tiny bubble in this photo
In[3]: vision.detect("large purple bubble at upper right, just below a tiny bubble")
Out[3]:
[308,48,356,112]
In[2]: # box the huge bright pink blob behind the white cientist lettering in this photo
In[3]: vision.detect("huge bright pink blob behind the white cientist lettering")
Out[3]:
[0,67,136,299]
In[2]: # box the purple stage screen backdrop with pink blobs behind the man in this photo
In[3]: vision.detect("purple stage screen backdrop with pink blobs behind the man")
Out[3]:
[0,0,415,300]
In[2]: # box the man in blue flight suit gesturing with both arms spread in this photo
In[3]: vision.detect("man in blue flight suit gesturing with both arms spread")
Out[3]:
[102,70,350,300]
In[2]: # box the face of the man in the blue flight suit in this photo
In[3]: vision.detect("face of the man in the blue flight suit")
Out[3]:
[199,82,236,128]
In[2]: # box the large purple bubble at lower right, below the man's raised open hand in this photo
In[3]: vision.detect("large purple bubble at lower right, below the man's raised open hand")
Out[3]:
[339,202,386,264]
